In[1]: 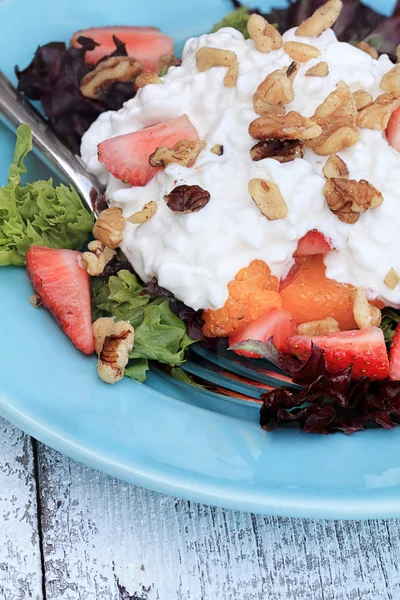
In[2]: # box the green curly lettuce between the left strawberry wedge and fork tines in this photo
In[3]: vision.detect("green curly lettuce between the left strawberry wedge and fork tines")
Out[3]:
[92,270,194,381]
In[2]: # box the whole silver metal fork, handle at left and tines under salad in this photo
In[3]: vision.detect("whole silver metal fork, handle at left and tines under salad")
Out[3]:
[0,71,299,406]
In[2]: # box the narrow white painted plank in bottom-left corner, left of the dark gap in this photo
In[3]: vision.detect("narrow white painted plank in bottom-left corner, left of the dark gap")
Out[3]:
[0,418,43,600]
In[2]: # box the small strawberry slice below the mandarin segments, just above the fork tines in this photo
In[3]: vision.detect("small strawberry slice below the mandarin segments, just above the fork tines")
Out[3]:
[229,308,297,358]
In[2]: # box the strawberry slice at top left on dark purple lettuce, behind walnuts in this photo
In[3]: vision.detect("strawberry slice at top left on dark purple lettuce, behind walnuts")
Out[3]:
[71,27,174,71]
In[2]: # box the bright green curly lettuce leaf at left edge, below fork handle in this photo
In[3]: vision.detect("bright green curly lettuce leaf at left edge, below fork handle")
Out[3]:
[0,124,94,266]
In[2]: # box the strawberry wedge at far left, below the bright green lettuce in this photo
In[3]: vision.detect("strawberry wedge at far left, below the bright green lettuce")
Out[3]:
[26,246,94,354]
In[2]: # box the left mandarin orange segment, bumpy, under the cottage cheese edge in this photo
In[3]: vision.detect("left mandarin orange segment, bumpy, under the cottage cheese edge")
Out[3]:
[203,260,282,337]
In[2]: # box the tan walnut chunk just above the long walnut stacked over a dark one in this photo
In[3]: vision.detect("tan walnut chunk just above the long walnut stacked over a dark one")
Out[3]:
[253,62,298,115]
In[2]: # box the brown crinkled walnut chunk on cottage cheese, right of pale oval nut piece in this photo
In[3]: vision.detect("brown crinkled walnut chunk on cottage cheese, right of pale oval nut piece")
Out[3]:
[324,177,383,224]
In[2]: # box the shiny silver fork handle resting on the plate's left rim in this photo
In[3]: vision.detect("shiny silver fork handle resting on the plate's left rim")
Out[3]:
[0,71,103,212]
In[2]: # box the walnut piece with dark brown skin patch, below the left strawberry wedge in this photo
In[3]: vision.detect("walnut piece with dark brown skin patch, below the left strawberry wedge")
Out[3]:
[93,317,134,383]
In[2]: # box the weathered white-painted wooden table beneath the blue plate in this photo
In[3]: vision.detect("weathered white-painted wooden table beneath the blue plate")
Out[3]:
[0,419,400,600]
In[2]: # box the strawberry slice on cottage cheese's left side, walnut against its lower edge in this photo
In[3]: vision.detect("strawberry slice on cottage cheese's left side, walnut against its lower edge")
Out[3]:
[98,115,199,185]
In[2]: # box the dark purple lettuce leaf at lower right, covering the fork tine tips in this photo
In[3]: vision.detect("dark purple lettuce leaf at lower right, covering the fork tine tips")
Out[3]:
[259,341,400,434]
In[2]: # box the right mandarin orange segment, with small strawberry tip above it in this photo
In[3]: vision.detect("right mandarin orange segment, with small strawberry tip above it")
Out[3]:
[280,255,358,330]
